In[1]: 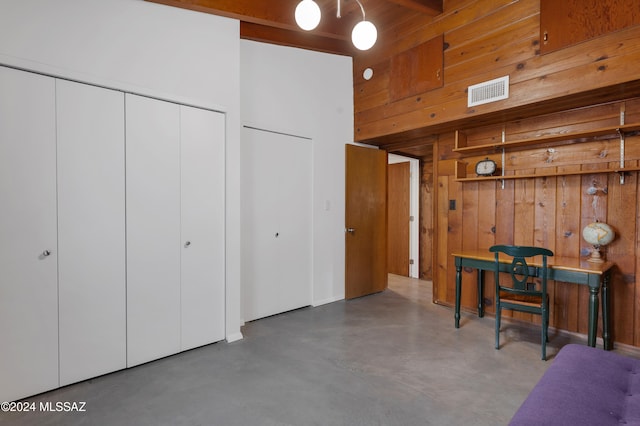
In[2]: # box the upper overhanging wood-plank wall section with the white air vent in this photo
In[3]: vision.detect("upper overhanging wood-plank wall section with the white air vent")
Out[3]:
[354,0,640,145]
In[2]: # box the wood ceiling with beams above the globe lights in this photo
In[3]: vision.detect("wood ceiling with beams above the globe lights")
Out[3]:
[147,0,443,56]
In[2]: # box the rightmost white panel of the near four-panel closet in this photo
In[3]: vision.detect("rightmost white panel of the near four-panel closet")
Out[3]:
[180,106,225,350]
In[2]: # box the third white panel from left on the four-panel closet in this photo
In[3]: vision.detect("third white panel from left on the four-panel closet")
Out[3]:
[126,94,182,366]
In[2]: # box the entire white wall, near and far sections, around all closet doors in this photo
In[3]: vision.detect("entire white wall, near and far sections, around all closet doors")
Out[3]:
[0,0,353,341]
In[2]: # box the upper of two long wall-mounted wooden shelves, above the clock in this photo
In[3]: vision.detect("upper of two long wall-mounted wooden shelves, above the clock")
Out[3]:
[453,124,640,153]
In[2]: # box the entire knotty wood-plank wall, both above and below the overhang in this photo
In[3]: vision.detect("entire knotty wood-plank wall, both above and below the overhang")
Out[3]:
[354,0,640,346]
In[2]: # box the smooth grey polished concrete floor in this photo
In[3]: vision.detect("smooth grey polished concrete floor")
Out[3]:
[0,276,580,426]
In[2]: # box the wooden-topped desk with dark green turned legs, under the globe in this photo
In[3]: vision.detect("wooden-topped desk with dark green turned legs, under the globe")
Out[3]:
[452,250,614,350]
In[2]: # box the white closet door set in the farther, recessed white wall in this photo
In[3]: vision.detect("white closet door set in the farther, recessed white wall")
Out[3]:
[241,128,312,321]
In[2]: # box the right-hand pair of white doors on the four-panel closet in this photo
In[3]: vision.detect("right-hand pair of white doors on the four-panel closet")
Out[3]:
[126,95,225,366]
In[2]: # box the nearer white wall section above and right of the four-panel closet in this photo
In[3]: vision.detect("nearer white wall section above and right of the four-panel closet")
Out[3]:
[0,0,242,341]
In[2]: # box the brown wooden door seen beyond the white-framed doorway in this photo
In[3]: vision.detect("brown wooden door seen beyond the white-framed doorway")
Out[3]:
[387,162,411,277]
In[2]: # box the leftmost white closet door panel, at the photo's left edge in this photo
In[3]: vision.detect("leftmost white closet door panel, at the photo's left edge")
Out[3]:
[0,67,58,401]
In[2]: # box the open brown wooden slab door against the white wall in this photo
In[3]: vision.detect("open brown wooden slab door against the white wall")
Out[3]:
[345,145,387,299]
